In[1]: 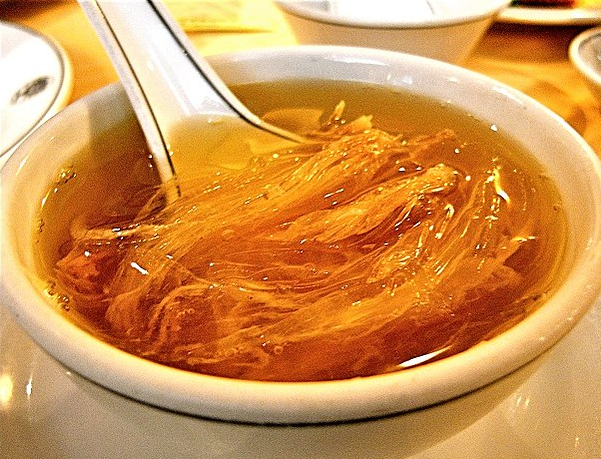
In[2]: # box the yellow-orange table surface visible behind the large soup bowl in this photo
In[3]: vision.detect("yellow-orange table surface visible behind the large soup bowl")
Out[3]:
[0,0,601,155]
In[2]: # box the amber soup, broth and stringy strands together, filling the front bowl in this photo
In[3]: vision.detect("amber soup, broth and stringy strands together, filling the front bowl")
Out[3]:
[39,81,566,381]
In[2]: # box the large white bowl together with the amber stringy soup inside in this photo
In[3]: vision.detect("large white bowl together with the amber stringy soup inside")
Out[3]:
[1,47,601,441]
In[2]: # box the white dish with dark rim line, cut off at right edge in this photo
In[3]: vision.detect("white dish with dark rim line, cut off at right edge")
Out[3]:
[569,27,601,100]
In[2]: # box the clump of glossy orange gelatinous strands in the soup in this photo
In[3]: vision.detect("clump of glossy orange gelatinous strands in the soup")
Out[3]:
[57,106,556,381]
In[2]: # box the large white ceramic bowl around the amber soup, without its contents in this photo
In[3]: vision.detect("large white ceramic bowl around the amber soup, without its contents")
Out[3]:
[0,47,601,457]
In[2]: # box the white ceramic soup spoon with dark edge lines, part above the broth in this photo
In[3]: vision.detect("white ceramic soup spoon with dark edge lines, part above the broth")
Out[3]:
[79,0,302,191]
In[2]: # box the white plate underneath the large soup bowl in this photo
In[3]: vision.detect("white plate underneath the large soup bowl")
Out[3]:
[0,300,601,459]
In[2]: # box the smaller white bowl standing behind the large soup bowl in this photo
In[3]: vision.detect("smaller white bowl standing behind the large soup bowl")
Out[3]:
[276,0,510,64]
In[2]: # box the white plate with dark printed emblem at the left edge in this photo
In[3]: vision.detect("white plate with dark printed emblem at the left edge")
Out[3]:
[0,21,72,164]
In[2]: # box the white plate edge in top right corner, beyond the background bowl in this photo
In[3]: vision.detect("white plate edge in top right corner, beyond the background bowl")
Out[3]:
[497,6,601,26]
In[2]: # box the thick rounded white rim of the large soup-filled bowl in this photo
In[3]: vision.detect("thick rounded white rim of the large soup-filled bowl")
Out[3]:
[0,46,601,424]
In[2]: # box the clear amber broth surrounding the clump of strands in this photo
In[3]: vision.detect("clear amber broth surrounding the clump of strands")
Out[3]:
[37,81,566,380]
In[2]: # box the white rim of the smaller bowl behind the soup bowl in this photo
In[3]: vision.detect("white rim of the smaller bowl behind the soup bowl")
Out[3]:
[275,0,511,29]
